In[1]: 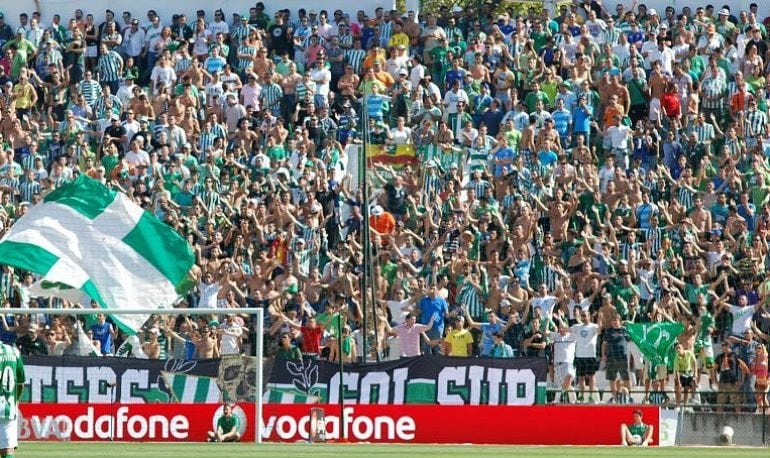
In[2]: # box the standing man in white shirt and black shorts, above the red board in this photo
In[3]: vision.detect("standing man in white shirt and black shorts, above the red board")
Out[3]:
[570,309,599,402]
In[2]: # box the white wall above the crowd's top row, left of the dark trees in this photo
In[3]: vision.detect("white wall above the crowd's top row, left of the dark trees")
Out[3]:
[0,0,395,27]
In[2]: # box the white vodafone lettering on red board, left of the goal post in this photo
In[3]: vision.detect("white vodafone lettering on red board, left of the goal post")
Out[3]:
[19,406,190,440]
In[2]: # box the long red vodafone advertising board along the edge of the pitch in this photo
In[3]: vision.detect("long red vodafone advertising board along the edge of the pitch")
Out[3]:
[20,404,660,445]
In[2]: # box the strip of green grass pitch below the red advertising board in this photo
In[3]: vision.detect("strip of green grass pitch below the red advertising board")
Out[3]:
[16,442,770,458]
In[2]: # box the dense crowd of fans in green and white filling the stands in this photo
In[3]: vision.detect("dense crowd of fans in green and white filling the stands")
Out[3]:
[0,0,770,410]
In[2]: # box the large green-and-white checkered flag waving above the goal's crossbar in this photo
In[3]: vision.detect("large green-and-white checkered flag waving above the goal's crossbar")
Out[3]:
[0,175,194,333]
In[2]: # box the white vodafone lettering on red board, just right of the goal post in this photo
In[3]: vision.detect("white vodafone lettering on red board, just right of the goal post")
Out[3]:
[262,407,416,441]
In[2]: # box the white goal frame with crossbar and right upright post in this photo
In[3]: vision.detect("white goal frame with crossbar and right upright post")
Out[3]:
[20,307,265,444]
